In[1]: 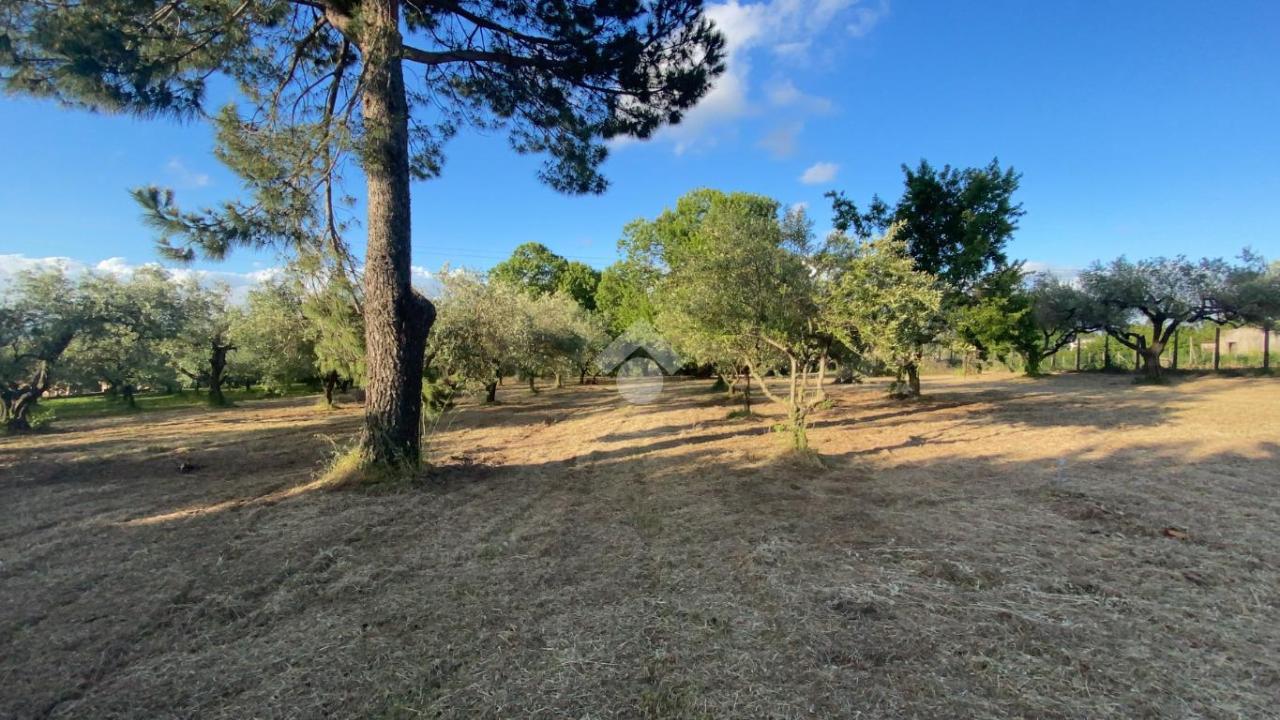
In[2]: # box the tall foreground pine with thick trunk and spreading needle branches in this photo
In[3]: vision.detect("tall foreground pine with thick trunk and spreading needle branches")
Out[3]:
[0,0,724,468]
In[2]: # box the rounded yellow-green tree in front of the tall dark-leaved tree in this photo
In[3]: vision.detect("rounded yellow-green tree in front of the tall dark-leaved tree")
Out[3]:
[823,227,945,397]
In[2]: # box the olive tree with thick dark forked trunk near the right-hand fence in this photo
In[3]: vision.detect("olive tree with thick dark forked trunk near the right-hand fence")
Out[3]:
[1080,255,1238,379]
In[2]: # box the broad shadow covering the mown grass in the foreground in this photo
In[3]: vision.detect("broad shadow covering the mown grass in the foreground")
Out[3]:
[10,409,1280,717]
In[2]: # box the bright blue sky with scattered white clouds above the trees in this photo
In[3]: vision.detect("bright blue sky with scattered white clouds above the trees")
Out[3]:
[0,0,1280,288]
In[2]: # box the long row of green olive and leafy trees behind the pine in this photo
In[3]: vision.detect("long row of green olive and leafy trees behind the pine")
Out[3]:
[0,160,1280,450]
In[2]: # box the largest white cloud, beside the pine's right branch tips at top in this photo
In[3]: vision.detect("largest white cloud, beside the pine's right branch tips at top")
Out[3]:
[622,0,888,154]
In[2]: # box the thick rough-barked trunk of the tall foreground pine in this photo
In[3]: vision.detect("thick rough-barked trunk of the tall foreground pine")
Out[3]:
[360,0,435,468]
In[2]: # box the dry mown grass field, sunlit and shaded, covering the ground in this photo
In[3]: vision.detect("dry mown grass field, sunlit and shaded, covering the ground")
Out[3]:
[0,375,1280,719]
